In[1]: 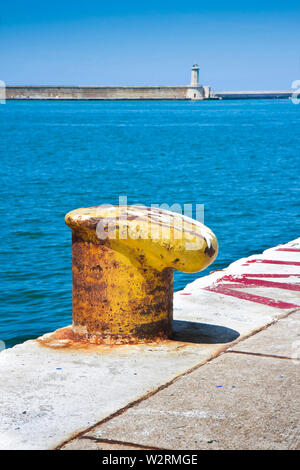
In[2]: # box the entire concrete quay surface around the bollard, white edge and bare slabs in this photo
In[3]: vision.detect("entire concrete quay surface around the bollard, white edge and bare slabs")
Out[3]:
[0,238,300,450]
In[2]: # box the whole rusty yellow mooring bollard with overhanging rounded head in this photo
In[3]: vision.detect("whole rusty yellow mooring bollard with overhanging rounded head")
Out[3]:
[65,206,218,344]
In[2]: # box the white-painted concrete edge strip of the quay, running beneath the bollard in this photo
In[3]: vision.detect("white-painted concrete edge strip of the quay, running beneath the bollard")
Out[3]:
[0,238,300,449]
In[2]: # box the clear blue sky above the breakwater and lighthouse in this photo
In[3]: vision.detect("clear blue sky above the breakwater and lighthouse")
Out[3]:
[0,0,300,90]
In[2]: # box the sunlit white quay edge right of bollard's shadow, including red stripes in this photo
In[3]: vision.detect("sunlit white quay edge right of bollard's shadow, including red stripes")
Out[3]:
[174,238,300,334]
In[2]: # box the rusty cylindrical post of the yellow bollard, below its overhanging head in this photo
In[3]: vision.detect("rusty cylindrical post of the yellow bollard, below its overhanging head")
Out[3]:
[73,232,173,342]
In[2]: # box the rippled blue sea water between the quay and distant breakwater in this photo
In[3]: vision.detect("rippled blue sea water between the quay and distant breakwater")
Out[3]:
[0,100,300,347]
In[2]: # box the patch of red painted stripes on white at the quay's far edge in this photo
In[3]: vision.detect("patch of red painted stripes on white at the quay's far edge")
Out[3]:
[181,238,300,310]
